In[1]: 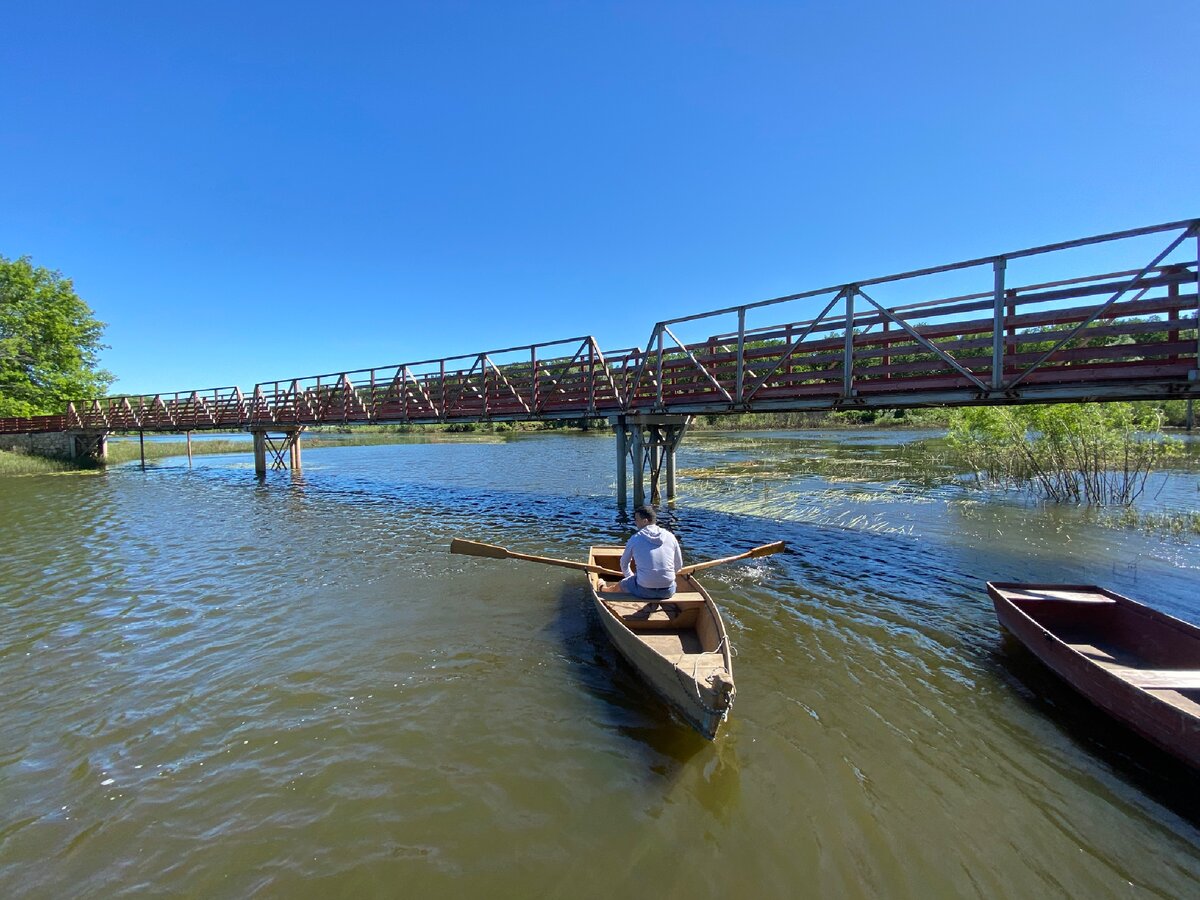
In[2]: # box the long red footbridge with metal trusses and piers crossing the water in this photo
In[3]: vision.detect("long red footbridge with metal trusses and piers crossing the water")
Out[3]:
[0,220,1200,503]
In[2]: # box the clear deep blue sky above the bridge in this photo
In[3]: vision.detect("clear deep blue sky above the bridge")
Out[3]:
[0,0,1200,392]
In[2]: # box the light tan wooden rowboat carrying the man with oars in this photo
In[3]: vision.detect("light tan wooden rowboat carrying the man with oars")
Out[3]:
[588,547,734,740]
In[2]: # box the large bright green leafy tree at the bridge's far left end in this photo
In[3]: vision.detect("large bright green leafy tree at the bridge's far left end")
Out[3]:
[0,256,113,416]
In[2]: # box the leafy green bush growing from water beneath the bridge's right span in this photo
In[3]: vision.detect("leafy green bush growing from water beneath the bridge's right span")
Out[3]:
[947,403,1182,506]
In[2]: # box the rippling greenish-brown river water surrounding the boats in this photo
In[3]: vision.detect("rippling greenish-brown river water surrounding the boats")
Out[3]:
[0,432,1200,899]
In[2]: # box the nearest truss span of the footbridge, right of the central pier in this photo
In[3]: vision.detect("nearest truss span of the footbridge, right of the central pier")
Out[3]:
[625,220,1200,412]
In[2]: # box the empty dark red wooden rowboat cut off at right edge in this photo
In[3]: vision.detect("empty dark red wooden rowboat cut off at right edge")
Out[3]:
[988,582,1200,768]
